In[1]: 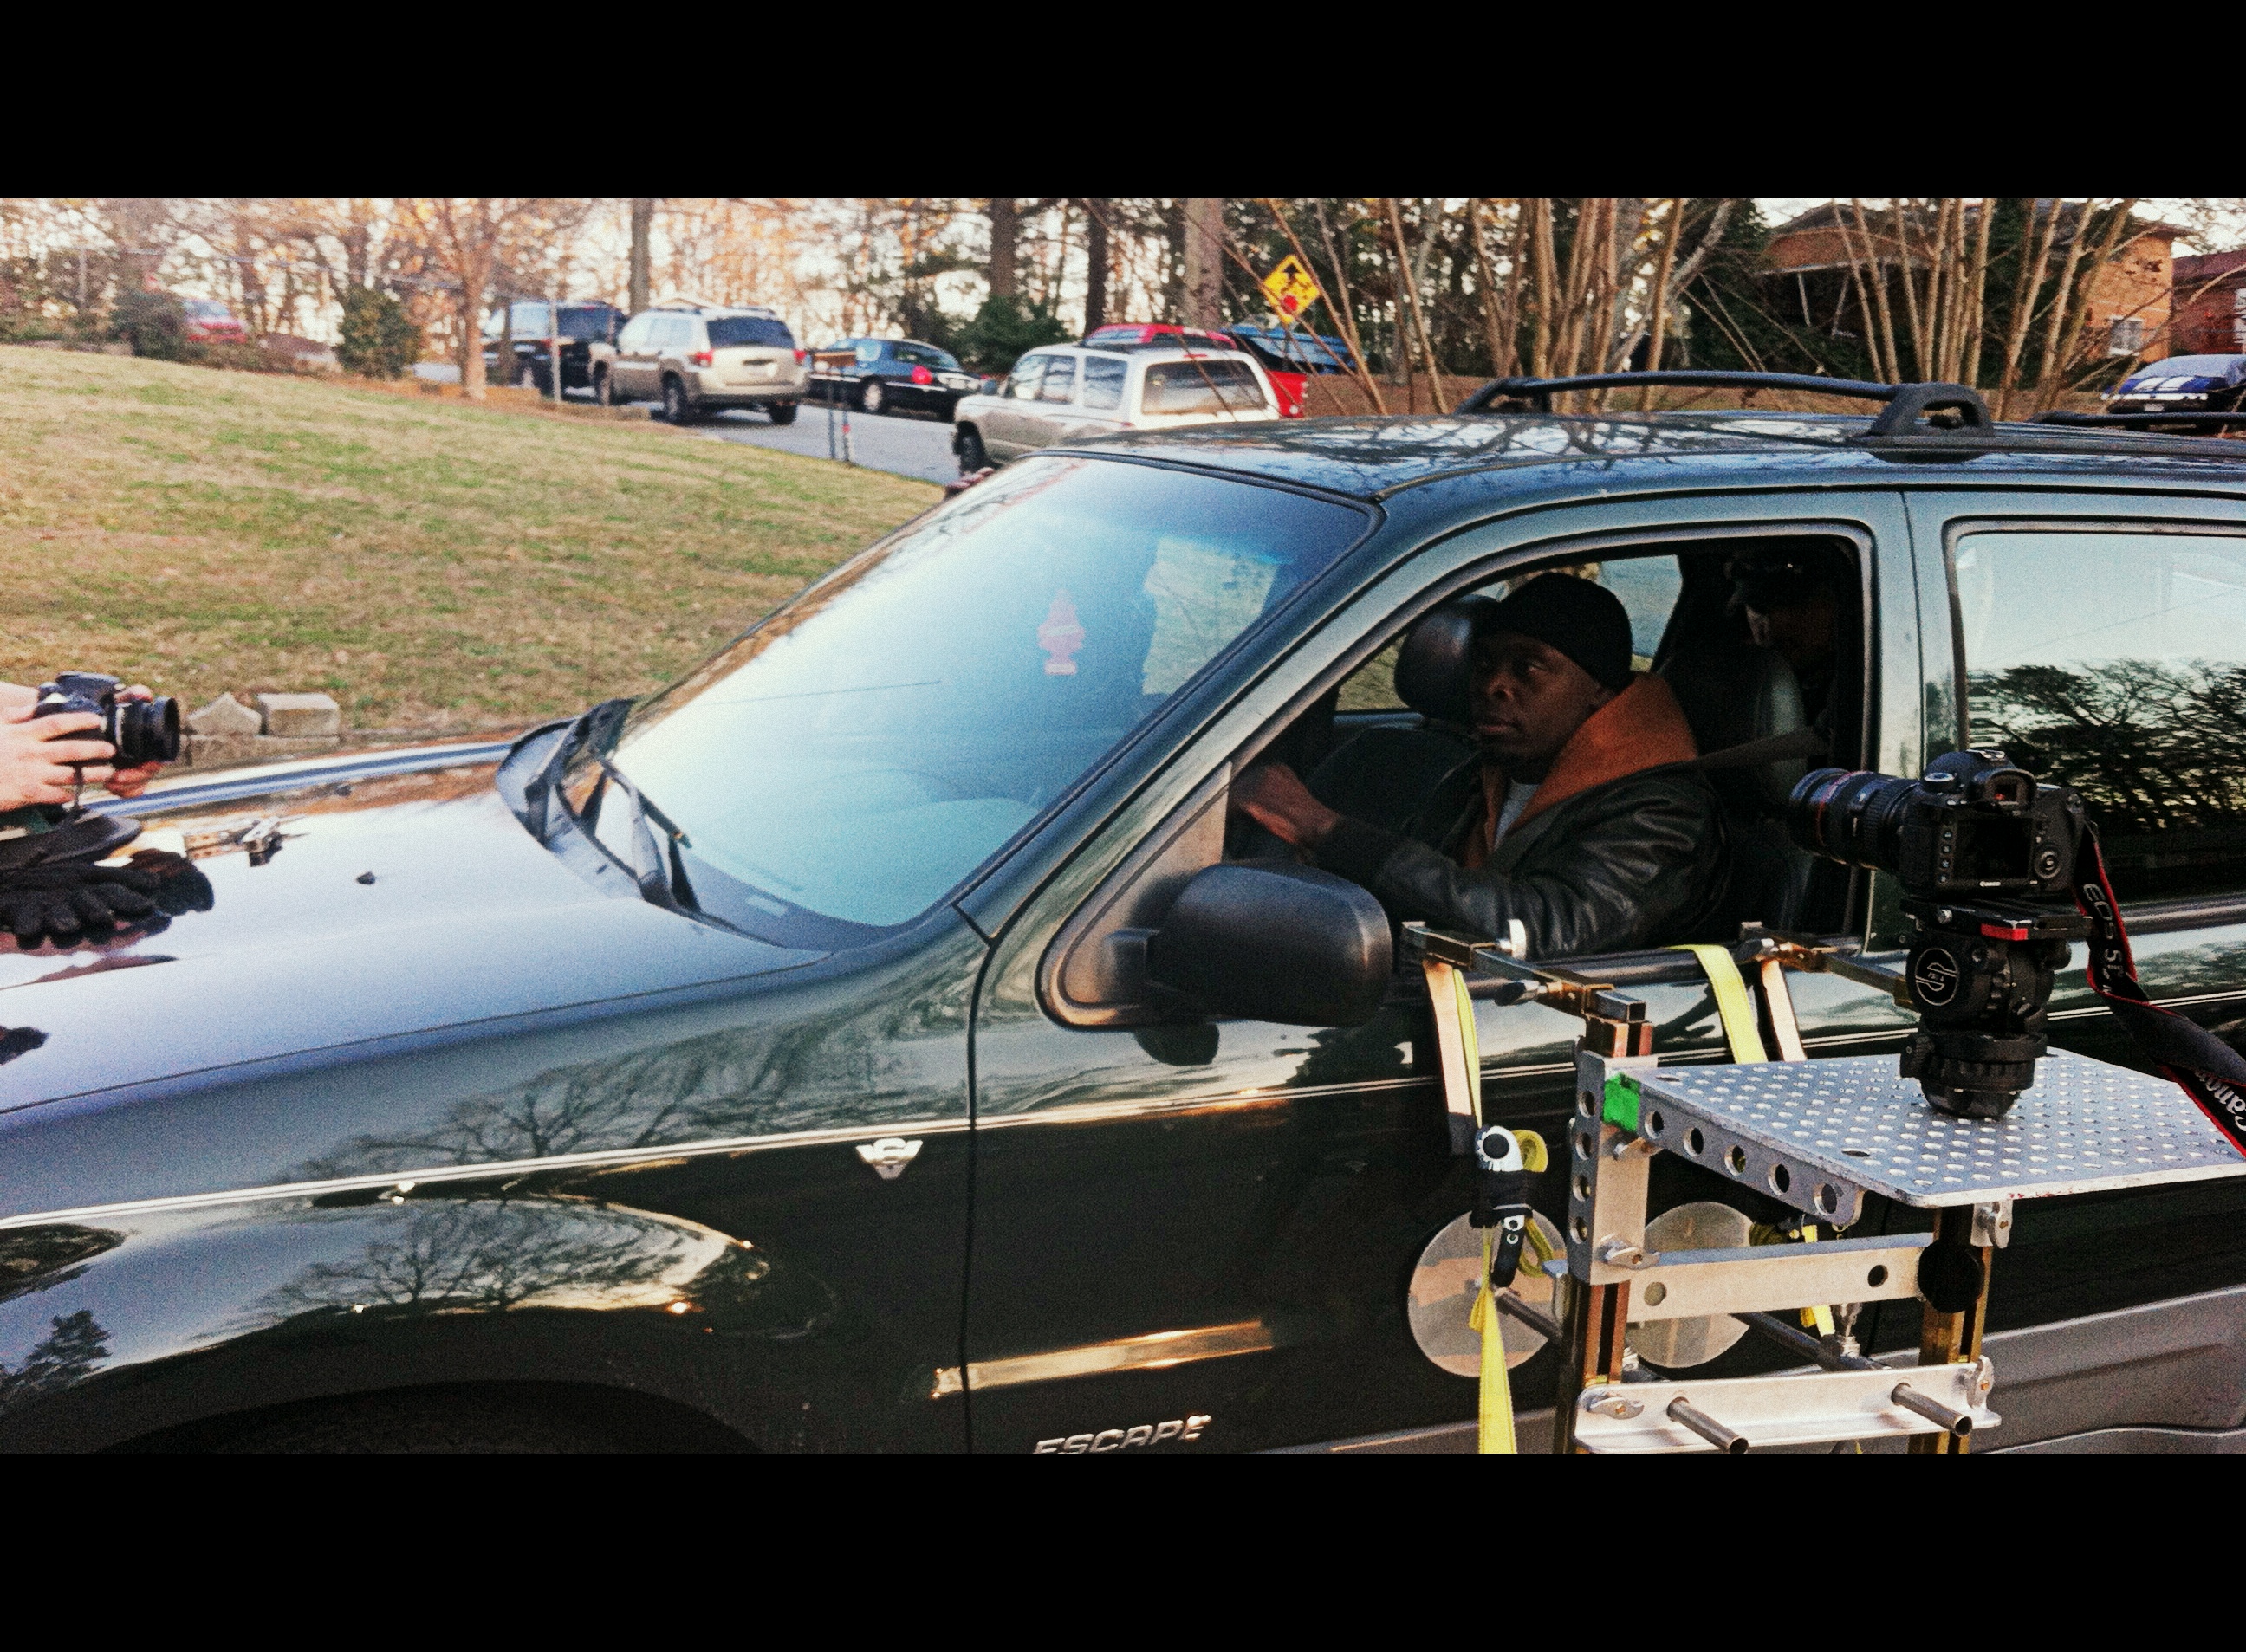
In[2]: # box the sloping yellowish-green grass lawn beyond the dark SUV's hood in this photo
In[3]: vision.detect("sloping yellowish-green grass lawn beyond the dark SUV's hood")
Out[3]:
[0,348,938,729]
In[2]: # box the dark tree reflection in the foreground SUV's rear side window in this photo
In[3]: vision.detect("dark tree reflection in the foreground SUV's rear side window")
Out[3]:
[1970,660,2246,900]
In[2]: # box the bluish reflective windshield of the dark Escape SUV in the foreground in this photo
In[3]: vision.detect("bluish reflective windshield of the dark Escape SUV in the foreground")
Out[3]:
[573,456,1368,945]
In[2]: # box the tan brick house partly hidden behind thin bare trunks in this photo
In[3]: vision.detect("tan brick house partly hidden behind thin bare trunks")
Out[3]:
[1763,202,2174,364]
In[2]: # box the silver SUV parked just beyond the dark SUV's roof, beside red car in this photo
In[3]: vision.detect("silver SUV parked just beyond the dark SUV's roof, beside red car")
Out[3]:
[952,346,1278,476]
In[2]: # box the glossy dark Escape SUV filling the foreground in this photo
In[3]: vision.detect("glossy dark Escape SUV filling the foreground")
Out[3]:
[13,370,2246,1454]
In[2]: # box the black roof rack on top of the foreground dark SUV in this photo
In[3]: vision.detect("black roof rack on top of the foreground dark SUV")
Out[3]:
[1457,368,2246,460]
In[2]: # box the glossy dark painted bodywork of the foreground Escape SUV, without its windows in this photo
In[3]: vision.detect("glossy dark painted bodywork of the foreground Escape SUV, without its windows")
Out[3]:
[13,415,2246,1450]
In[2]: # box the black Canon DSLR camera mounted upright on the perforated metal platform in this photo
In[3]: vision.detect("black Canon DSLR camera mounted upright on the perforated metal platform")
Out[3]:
[1788,752,2089,1118]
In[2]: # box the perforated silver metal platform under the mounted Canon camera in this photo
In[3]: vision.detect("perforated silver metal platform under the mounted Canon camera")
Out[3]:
[1631,1053,2246,1221]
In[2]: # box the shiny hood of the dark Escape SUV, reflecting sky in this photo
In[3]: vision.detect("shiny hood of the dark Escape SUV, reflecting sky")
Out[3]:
[0,759,820,1111]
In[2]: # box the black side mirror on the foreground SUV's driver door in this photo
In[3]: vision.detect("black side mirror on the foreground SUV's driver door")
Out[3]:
[1146,859,1395,1026]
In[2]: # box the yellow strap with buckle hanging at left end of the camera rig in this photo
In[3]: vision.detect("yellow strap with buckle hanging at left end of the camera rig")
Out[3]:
[1424,958,1549,1457]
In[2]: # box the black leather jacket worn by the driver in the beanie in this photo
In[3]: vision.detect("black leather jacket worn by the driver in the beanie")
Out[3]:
[1319,756,1730,958]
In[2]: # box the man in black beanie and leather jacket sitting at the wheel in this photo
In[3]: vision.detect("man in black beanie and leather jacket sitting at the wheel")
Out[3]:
[1233,574,1725,958]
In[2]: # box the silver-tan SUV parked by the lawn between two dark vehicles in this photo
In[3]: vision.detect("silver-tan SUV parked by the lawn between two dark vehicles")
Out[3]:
[593,303,808,424]
